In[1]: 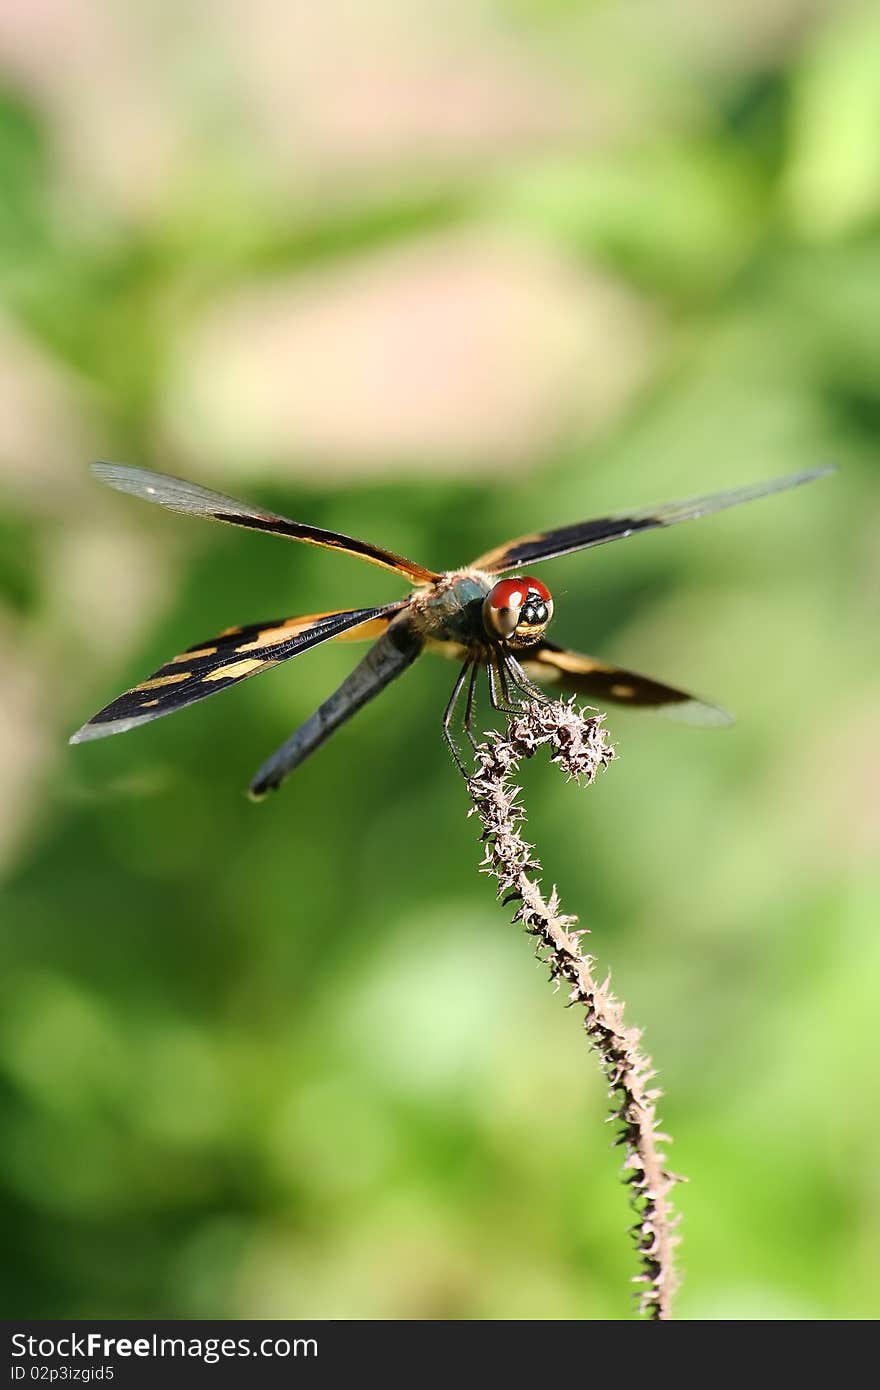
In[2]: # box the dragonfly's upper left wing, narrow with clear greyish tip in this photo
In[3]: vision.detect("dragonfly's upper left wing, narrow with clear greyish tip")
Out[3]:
[92,463,437,584]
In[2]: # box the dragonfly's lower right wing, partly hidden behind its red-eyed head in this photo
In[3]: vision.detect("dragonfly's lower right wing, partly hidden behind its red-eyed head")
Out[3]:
[523,642,733,728]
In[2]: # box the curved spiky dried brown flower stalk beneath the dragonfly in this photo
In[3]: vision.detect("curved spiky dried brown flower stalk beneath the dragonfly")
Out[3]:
[468,701,681,1319]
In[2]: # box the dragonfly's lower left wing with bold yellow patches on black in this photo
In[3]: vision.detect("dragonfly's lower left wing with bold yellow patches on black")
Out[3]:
[71,600,409,744]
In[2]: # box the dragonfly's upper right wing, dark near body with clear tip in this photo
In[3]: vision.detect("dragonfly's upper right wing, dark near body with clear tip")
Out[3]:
[474,466,836,574]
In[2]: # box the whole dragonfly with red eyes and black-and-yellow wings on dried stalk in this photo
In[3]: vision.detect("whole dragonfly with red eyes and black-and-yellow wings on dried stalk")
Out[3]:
[71,463,834,799]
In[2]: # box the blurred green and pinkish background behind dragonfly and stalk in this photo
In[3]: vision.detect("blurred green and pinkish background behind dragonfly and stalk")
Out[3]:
[0,0,880,1319]
